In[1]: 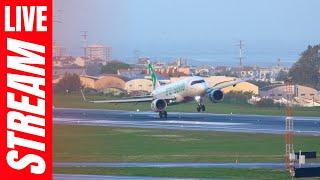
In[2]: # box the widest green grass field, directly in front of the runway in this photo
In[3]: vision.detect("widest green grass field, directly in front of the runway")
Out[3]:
[53,125,320,162]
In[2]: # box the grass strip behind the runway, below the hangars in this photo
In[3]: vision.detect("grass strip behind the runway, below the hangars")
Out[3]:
[53,94,320,116]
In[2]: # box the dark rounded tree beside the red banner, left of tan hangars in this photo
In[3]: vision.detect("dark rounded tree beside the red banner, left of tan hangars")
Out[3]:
[54,73,81,92]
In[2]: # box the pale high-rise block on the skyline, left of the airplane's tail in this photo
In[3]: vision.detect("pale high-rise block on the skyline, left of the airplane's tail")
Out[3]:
[86,44,112,64]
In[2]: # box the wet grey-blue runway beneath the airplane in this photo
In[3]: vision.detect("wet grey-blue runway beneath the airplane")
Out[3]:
[53,108,320,136]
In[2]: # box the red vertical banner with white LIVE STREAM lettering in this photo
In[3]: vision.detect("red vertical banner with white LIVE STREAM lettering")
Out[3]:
[0,0,52,180]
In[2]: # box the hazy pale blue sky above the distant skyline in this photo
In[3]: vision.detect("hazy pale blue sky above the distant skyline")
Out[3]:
[54,0,320,65]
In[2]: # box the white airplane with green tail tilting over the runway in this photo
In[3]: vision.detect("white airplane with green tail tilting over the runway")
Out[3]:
[81,63,249,118]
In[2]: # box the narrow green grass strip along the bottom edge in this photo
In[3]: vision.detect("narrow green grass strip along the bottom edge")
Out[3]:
[54,168,290,179]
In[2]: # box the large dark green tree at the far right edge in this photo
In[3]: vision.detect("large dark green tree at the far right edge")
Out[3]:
[289,45,320,90]
